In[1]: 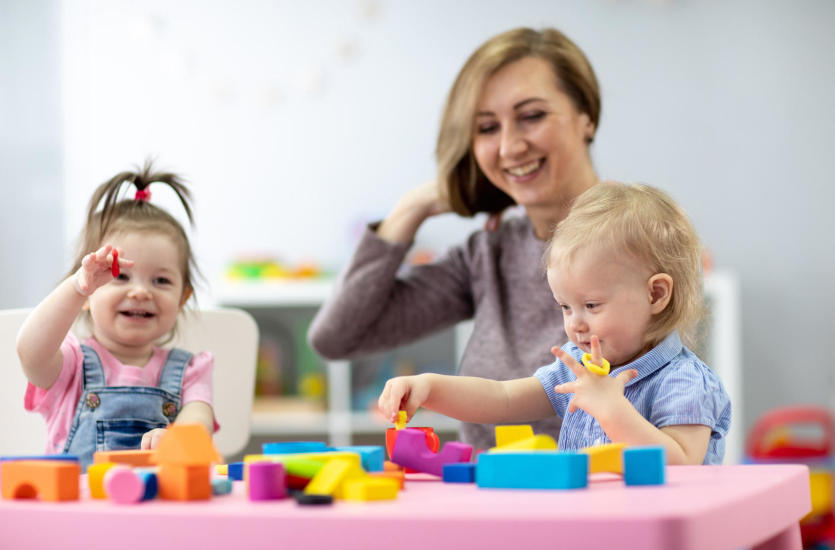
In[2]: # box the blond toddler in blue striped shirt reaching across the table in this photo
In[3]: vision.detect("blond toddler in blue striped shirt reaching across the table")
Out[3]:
[379,183,731,464]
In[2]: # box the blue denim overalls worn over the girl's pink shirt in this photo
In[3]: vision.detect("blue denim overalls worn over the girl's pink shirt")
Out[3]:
[64,345,191,470]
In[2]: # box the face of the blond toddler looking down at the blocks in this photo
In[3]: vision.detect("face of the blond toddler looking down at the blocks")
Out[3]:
[548,246,653,367]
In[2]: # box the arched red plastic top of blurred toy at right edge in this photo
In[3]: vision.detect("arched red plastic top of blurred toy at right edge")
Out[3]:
[745,406,835,461]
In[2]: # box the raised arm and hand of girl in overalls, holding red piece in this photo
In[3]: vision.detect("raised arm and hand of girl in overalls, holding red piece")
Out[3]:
[17,244,125,389]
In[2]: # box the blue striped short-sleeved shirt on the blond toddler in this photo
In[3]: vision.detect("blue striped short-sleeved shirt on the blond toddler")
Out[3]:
[534,331,731,464]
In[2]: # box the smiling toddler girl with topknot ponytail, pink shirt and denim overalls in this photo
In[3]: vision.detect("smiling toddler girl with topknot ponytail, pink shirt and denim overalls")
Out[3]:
[17,163,216,468]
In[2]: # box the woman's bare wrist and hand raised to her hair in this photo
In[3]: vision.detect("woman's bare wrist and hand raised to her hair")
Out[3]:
[377,180,452,243]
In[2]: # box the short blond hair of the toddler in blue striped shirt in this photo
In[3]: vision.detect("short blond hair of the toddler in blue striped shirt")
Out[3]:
[545,182,704,346]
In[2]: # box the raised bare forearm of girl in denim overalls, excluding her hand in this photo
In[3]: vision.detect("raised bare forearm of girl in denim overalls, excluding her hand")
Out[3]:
[17,275,87,390]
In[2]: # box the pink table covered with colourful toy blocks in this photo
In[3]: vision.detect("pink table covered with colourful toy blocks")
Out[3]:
[0,465,811,550]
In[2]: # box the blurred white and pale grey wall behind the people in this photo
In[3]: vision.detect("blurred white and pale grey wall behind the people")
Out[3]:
[0,0,835,444]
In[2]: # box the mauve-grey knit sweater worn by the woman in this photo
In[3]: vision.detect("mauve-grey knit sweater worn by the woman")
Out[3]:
[308,217,567,449]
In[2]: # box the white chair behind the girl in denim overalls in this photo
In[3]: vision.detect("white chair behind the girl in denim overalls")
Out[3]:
[0,308,258,457]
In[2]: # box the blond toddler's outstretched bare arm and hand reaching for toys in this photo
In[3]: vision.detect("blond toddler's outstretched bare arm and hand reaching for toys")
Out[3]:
[378,373,554,424]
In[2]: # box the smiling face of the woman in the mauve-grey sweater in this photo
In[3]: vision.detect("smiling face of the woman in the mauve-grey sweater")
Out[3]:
[473,57,596,213]
